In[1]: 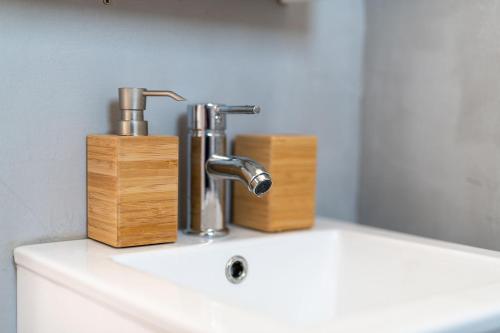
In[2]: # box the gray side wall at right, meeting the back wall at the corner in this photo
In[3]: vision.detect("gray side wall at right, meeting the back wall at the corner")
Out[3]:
[360,0,500,250]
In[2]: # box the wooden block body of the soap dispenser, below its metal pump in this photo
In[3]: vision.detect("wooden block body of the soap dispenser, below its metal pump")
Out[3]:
[87,135,178,247]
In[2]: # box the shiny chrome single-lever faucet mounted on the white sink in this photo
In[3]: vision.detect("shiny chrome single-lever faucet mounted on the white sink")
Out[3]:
[186,104,272,237]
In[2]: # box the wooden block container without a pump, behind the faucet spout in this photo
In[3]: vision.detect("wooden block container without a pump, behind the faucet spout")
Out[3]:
[233,135,317,232]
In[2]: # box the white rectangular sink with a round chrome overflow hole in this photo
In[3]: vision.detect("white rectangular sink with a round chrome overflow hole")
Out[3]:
[15,219,500,333]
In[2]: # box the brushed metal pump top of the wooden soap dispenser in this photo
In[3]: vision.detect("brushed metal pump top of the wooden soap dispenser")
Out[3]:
[118,88,184,136]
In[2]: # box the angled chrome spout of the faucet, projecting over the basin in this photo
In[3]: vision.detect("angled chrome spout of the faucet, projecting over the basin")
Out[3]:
[206,155,272,197]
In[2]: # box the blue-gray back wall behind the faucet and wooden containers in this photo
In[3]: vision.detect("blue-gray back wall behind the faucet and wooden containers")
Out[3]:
[0,0,364,333]
